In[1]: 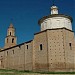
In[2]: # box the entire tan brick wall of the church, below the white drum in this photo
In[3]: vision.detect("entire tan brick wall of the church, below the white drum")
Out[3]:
[0,28,75,71]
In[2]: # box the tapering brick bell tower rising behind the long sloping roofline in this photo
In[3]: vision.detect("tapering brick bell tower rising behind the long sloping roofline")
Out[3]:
[4,23,17,48]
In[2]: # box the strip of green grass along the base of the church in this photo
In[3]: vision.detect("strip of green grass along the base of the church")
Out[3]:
[0,69,75,75]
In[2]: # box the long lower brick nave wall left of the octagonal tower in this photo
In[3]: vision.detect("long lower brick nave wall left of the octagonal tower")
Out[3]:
[0,41,33,70]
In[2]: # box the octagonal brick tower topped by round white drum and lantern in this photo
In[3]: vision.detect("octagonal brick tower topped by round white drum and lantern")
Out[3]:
[34,5,75,72]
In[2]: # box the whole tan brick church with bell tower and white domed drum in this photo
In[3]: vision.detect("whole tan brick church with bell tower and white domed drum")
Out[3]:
[0,6,75,71]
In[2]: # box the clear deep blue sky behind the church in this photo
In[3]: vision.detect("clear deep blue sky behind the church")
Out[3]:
[0,0,75,47]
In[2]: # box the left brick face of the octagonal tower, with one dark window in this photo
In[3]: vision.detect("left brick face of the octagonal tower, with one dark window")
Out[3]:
[34,31,48,71]
